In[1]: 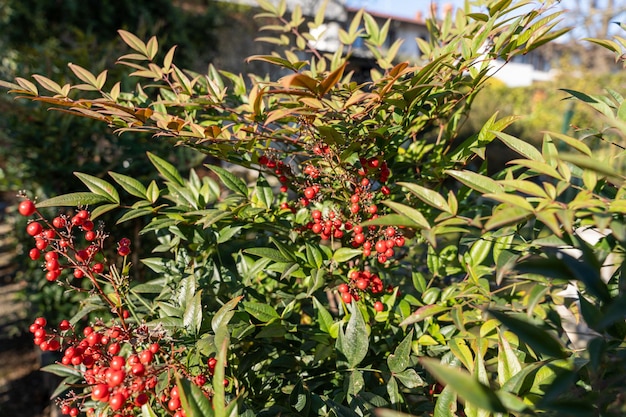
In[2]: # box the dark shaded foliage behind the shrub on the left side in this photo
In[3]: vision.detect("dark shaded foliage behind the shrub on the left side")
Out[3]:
[0,0,223,319]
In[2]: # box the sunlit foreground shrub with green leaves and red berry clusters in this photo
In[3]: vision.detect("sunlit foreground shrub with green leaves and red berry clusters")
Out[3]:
[4,0,626,417]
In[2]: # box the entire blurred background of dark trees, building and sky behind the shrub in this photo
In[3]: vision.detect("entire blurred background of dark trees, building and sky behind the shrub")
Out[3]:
[0,0,626,417]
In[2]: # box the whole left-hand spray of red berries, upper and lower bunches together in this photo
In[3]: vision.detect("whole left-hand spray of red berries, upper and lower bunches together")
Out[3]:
[18,199,228,417]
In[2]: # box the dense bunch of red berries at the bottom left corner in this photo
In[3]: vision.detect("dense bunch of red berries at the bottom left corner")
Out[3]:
[30,317,176,417]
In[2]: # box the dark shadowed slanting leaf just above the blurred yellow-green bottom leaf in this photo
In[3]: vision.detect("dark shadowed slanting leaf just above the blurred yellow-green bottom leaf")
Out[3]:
[489,310,567,358]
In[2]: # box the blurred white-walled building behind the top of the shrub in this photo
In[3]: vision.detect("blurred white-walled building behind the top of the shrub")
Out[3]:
[210,0,563,87]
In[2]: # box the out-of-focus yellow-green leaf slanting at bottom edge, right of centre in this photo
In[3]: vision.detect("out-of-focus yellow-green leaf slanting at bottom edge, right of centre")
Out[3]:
[420,358,506,413]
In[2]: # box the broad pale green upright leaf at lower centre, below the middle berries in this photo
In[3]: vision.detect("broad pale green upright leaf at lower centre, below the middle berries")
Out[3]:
[336,302,369,369]
